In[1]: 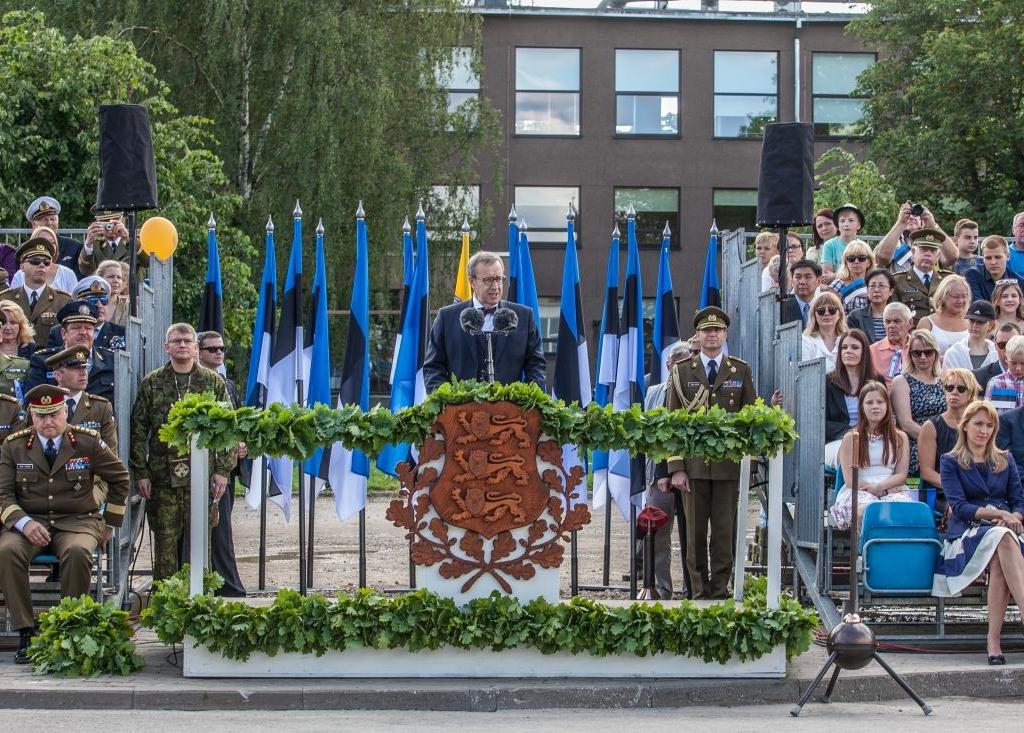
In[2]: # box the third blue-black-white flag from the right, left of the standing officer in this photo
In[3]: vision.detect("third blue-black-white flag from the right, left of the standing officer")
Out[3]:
[608,205,645,518]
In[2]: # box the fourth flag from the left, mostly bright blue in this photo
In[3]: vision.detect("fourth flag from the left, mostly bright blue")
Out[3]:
[302,220,331,507]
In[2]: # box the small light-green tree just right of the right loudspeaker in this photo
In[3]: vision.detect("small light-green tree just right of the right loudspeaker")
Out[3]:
[814,147,899,234]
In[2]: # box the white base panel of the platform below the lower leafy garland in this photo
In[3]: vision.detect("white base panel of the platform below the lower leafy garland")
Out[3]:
[183,637,785,679]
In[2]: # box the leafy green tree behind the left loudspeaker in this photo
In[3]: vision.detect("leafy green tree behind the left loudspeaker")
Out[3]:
[0,12,258,350]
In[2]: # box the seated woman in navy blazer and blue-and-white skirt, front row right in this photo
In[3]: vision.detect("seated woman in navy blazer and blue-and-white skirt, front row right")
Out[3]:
[932,401,1024,664]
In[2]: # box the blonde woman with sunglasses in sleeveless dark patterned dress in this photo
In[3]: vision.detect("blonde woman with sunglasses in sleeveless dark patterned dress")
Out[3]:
[891,329,946,476]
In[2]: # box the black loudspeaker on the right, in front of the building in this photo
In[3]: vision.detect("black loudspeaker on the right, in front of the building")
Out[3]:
[758,122,814,226]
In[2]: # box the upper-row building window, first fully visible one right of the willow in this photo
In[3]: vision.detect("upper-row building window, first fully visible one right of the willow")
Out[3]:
[515,48,580,135]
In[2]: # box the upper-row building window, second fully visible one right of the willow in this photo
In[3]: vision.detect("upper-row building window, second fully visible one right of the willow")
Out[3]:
[615,48,679,135]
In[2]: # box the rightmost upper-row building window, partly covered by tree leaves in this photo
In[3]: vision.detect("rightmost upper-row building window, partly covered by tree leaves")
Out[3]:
[811,53,874,137]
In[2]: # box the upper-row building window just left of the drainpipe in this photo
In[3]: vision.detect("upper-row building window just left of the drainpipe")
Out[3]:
[715,51,778,137]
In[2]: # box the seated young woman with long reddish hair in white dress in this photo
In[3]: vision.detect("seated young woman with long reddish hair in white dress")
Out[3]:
[828,382,912,529]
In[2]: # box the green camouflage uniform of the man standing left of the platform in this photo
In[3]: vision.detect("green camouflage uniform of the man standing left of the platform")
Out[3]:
[130,361,236,580]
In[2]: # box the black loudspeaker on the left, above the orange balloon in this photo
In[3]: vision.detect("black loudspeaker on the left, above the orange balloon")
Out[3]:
[96,104,157,211]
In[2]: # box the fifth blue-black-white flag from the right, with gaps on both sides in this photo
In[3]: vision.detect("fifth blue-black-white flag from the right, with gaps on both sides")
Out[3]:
[552,206,591,504]
